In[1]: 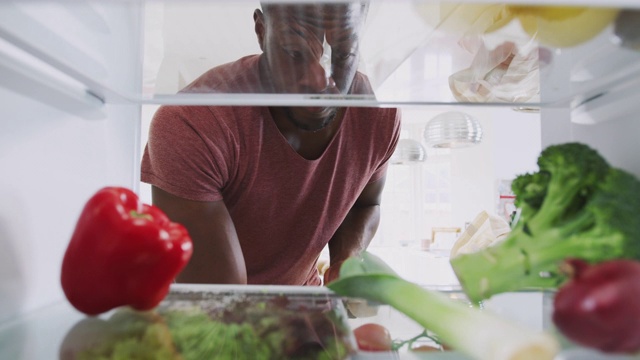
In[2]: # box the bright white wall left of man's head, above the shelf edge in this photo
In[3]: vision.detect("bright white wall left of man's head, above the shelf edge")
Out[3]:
[147,1,260,94]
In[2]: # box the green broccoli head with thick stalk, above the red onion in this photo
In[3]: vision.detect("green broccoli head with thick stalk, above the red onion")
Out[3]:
[451,143,640,301]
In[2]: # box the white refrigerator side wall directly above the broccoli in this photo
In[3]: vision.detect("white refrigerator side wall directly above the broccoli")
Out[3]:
[540,25,640,176]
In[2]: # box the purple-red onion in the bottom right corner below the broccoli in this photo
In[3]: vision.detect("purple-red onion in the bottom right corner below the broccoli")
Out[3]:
[552,259,640,354]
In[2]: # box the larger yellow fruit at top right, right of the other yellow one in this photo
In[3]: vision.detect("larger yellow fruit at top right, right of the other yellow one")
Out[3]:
[507,5,619,48]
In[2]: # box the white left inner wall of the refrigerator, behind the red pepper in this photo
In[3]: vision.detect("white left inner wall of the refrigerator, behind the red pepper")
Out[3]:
[0,2,142,321]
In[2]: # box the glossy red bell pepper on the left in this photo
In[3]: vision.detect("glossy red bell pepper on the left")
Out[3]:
[61,187,193,315]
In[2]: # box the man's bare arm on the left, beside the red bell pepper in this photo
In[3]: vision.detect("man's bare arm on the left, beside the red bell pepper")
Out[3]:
[151,186,247,284]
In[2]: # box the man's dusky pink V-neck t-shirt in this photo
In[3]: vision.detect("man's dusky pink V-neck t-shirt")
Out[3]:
[141,57,400,285]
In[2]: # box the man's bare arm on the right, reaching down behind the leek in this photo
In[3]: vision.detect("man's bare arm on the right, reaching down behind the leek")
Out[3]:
[324,176,385,284]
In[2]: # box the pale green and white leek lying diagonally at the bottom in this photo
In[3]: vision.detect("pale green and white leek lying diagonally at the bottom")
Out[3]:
[327,251,559,360]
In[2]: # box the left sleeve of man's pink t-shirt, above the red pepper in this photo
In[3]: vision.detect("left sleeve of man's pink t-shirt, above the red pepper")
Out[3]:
[140,106,233,201]
